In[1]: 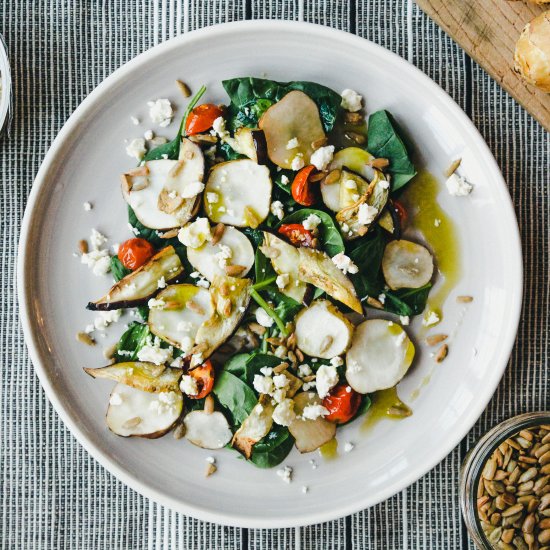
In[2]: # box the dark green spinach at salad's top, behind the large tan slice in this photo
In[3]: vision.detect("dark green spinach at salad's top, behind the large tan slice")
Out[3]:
[222,77,342,132]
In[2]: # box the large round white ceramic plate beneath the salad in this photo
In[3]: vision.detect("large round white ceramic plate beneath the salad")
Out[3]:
[19,21,522,527]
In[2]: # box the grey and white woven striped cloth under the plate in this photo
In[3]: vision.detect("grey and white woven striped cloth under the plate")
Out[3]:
[0,0,550,550]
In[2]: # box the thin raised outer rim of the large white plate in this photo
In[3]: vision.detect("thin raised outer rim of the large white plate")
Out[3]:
[16,19,523,528]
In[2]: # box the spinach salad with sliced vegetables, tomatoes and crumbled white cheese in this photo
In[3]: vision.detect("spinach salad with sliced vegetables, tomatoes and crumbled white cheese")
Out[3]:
[81,77,458,474]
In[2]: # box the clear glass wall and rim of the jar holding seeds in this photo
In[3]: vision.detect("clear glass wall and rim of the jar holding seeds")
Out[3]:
[459,411,550,550]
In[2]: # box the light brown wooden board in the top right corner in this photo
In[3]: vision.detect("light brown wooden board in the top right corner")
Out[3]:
[416,0,550,132]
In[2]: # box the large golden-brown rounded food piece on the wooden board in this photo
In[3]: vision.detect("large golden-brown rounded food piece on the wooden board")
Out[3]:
[514,11,550,92]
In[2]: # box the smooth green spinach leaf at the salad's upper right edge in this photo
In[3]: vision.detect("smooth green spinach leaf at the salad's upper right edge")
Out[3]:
[367,111,416,192]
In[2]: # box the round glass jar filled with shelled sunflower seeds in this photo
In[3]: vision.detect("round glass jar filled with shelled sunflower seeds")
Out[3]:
[460,411,550,550]
